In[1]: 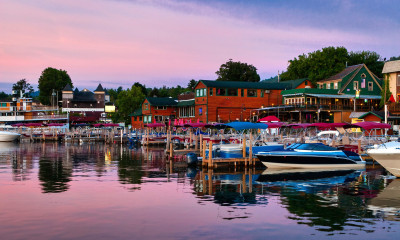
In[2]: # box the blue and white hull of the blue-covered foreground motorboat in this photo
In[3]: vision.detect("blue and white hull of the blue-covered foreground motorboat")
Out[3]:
[256,152,365,169]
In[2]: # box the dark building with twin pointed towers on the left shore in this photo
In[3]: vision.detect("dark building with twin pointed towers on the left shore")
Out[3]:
[62,84,109,123]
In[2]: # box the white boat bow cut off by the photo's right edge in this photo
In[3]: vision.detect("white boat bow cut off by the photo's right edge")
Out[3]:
[367,142,400,177]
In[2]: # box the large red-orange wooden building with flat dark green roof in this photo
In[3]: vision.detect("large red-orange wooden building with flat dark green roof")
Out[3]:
[194,80,291,122]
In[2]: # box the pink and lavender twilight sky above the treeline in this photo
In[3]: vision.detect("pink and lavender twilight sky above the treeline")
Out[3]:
[0,0,400,92]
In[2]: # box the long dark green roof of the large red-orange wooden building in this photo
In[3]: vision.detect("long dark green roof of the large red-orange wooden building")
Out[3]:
[196,80,291,90]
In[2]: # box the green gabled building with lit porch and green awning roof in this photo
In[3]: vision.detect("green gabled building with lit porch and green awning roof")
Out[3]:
[274,64,382,122]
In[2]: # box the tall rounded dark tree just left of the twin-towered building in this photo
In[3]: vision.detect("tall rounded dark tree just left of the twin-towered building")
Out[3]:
[39,67,73,105]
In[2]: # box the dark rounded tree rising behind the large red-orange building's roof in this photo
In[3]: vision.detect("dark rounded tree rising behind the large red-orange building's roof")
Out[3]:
[215,59,260,82]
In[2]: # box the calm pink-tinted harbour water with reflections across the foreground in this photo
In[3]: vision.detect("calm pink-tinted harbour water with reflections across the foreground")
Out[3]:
[0,143,400,240]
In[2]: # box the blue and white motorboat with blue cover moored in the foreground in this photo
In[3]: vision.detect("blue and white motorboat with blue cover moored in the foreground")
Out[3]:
[256,143,365,169]
